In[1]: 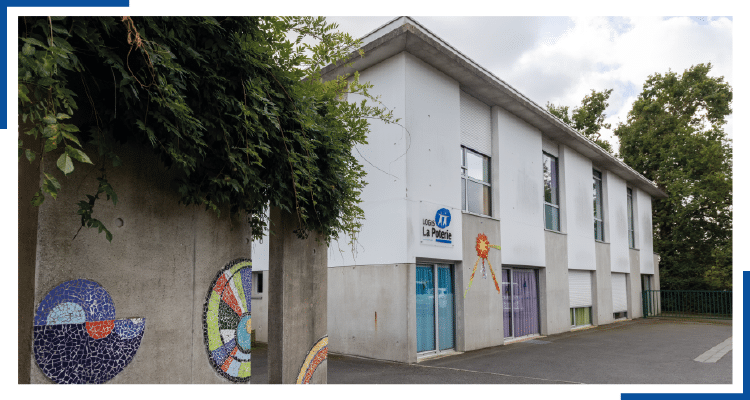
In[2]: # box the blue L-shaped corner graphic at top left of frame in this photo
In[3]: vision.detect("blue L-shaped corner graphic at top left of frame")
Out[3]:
[0,0,130,129]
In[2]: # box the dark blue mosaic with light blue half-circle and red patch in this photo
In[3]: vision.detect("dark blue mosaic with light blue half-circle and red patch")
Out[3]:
[33,279,146,383]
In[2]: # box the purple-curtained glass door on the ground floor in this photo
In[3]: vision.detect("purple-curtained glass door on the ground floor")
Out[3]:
[503,269,539,337]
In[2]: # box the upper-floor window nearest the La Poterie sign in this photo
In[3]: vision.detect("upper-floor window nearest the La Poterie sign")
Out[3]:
[461,147,492,215]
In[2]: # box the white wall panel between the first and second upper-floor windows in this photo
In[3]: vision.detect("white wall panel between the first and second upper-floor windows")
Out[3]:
[492,107,545,266]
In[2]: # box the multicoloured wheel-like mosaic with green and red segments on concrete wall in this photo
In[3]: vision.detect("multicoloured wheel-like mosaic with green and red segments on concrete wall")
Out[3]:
[203,258,253,382]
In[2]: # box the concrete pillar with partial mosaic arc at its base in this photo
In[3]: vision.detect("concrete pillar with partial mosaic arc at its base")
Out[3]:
[268,207,328,383]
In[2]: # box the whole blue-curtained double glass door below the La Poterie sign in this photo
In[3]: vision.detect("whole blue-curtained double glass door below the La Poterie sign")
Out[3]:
[416,264,456,353]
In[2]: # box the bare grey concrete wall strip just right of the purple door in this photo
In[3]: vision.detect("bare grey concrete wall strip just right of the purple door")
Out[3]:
[539,231,570,335]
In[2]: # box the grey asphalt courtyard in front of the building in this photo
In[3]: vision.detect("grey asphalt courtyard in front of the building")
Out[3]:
[251,319,732,384]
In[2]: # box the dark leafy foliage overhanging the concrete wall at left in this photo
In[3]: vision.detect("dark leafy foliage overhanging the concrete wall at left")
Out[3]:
[18,17,394,241]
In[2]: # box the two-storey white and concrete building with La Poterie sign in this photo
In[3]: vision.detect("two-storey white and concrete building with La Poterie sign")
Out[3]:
[253,17,666,362]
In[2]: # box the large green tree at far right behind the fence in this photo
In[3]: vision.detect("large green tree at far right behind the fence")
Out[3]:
[615,63,732,289]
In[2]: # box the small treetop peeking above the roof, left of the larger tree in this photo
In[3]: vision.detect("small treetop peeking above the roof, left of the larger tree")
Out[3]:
[547,89,612,153]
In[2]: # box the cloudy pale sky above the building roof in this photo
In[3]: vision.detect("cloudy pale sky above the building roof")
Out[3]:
[327,16,734,150]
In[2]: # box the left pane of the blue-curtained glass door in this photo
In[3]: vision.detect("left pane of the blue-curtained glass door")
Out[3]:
[417,265,435,353]
